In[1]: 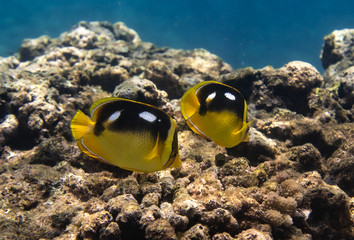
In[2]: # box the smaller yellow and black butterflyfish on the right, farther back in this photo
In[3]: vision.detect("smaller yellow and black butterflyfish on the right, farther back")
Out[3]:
[181,81,250,148]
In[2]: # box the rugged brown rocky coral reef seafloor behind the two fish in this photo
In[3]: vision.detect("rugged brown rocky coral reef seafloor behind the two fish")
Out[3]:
[0,22,354,240]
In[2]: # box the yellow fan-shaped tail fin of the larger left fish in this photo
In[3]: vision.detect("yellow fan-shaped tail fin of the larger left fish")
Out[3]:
[70,110,94,140]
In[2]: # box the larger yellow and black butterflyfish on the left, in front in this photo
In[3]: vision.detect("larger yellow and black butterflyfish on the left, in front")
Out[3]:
[71,98,181,172]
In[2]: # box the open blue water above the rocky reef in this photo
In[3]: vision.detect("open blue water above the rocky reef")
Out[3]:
[0,0,354,71]
